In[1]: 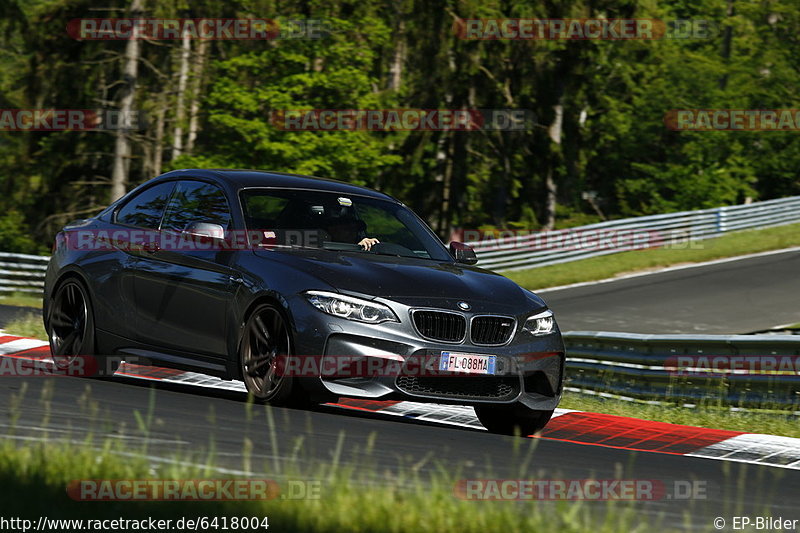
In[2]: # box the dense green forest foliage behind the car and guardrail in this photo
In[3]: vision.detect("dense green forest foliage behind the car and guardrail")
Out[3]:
[0,0,800,245]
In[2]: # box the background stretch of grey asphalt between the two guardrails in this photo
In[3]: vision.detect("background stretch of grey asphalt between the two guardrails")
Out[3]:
[541,251,800,335]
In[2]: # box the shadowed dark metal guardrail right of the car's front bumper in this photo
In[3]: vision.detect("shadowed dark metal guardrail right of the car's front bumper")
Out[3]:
[564,331,800,408]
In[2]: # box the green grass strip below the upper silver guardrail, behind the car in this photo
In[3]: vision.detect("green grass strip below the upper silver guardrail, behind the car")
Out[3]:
[503,220,800,289]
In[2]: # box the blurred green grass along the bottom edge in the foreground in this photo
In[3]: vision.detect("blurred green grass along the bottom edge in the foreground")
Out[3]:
[0,445,652,533]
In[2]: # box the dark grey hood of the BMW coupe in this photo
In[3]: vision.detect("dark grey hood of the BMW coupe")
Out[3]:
[255,250,545,312]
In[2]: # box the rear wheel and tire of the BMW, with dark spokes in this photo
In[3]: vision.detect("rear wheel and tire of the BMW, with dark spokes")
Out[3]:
[46,278,120,377]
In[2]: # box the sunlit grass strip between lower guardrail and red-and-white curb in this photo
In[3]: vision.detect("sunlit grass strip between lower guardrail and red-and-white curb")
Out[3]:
[559,391,800,438]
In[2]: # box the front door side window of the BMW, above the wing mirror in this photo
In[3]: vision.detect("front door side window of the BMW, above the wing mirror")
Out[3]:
[161,181,231,232]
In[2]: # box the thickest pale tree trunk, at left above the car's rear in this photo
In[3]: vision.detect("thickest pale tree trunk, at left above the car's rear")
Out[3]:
[110,0,143,202]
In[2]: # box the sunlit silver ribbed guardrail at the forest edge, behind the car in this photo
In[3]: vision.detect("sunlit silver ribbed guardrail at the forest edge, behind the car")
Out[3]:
[472,196,800,270]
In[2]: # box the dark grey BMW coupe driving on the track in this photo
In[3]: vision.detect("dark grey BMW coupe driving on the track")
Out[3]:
[44,170,564,435]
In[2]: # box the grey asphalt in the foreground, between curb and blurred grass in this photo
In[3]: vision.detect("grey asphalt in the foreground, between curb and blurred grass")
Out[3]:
[0,377,800,530]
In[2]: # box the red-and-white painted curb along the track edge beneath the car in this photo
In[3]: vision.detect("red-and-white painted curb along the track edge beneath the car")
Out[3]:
[0,333,800,470]
